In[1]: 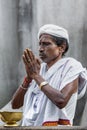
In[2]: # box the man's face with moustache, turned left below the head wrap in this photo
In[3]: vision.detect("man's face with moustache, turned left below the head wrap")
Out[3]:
[39,34,60,64]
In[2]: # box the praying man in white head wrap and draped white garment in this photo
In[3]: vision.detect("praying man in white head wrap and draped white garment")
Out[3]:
[12,24,87,126]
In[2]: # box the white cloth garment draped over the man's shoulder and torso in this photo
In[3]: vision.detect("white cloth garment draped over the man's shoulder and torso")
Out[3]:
[22,58,87,126]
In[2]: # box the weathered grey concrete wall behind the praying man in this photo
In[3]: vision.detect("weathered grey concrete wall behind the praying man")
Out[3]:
[0,0,87,125]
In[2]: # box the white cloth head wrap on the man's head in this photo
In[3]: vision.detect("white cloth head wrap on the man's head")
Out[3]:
[38,24,69,43]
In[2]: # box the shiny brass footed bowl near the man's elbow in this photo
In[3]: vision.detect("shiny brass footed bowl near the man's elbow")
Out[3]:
[0,111,22,126]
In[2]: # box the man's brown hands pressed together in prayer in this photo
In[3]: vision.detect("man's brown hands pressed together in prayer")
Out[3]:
[22,48,40,80]
